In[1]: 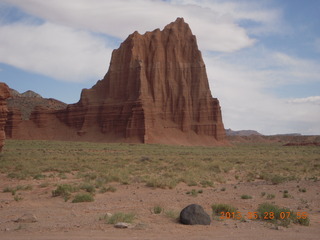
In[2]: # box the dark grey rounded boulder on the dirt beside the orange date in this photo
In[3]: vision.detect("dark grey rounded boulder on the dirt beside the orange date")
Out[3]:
[180,204,211,225]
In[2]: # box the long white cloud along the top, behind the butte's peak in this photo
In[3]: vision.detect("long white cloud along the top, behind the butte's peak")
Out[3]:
[2,0,255,52]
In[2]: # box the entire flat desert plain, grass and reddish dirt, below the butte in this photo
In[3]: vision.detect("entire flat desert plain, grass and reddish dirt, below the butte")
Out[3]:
[0,140,320,240]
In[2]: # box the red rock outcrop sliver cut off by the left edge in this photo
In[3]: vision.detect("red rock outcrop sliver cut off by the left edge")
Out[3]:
[0,82,10,152]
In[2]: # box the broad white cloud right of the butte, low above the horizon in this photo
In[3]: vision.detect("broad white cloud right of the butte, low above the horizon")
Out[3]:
[205,48,320,134]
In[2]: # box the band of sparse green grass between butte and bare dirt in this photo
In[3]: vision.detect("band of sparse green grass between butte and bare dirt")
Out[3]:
[0,140,320,188]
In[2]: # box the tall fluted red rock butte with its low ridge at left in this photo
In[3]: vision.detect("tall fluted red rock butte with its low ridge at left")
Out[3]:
[6,18,226,145]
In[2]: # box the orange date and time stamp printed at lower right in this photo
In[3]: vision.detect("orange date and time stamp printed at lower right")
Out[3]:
[220,211,308,220]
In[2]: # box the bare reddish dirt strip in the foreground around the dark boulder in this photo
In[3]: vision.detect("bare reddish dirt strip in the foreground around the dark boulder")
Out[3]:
[0,174,320,240]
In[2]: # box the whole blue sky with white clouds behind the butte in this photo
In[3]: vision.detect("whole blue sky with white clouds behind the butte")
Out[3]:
[0,0,320,135]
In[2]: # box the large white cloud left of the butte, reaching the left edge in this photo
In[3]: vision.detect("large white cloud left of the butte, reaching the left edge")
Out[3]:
[0,23,111,81]
